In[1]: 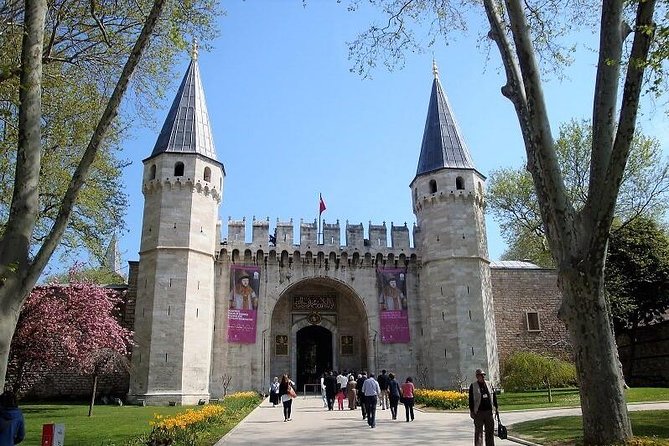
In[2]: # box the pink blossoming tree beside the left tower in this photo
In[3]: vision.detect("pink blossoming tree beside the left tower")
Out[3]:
[7,282,132,398]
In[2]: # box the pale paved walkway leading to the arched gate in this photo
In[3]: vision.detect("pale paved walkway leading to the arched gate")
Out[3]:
[215,396,669,446]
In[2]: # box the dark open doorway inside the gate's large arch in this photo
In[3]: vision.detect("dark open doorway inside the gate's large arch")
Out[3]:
[296,325,332,389]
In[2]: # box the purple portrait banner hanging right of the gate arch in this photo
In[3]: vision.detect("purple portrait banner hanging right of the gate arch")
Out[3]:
[376,268,410,344]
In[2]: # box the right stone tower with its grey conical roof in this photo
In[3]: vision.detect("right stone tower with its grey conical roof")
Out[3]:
[410,64,499,386]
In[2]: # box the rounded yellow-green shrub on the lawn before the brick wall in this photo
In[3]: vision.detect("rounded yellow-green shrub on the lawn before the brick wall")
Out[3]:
[502,351,576,403]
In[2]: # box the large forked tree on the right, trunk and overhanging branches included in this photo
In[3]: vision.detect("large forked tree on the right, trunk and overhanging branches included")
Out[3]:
[349,0,669,444]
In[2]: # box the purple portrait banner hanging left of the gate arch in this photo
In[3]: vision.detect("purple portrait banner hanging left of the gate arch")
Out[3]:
[228,265,260,344]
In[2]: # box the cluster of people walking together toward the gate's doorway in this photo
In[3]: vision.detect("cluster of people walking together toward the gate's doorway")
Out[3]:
[321,370,414,428]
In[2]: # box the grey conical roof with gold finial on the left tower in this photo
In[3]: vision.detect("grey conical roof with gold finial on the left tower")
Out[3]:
[150,47,217,161]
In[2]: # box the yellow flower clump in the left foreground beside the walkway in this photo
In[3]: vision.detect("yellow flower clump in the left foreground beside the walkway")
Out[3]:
[147,404,225,446]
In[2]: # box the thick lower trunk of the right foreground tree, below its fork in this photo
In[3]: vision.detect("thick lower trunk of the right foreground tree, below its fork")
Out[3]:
[559,260,632,445]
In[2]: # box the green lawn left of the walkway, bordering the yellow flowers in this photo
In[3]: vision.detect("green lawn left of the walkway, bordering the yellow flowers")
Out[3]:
[21,397,260,446]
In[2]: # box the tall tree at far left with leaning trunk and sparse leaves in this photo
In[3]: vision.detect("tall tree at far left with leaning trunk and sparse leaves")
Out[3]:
[0,0,216,392]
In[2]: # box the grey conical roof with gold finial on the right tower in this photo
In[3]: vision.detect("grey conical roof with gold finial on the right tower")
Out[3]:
[416,63,475,176]
